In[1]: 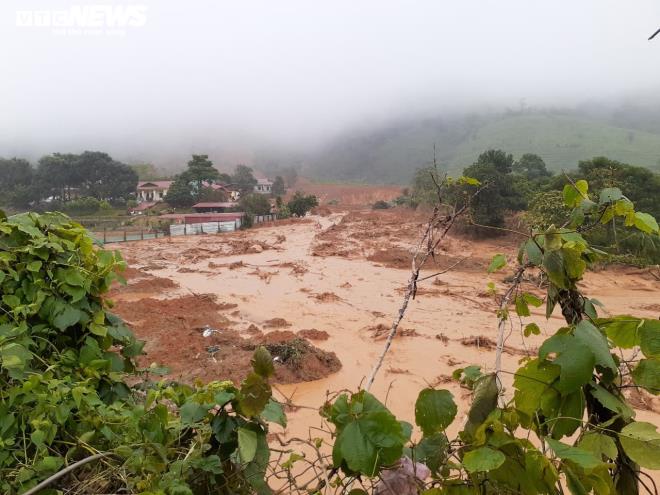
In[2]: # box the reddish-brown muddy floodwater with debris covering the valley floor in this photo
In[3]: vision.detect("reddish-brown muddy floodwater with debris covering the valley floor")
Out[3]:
[108,210,660,484]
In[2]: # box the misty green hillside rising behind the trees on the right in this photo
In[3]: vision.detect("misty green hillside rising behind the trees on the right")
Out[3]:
[310,112,660,183]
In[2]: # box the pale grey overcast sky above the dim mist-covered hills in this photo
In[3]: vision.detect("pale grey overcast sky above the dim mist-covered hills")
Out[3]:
[0,0,660,166]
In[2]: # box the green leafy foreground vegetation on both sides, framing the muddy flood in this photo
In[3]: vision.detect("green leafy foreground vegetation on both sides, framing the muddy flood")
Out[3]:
[0,173,660,495]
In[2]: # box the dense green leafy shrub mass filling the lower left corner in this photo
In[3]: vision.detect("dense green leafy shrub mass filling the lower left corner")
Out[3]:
[0,213,284,495]
